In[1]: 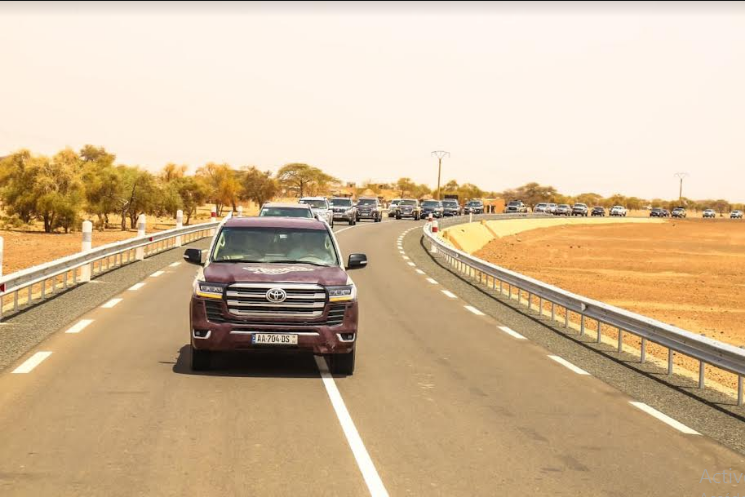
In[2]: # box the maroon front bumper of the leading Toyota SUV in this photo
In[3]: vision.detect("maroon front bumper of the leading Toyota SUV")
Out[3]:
[190,297,358,354]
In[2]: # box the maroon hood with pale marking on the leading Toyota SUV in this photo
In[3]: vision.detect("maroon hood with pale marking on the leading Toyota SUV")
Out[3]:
[202,262,348,286]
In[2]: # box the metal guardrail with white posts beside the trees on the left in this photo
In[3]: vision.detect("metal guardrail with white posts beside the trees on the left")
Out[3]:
[0,221,220,318]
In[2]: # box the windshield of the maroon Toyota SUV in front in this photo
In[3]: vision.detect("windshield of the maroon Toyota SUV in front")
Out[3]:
[210,228,339,266]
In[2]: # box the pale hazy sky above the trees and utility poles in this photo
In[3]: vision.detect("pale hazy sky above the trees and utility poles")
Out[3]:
[0,2,745,202]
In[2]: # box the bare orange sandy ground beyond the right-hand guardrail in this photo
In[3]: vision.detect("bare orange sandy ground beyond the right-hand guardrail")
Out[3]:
[475,219,745,392]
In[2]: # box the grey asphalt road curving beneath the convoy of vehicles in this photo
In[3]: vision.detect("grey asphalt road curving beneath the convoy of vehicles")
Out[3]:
[0,219,745,497]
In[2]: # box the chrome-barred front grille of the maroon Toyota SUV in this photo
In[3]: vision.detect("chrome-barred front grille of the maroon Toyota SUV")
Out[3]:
[225,283,326,320]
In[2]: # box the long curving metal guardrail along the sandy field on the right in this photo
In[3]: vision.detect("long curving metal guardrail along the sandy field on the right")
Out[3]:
[424,214,745,406]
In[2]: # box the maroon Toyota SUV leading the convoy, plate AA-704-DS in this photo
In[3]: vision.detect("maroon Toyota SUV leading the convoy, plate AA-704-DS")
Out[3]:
[184,217,367,375]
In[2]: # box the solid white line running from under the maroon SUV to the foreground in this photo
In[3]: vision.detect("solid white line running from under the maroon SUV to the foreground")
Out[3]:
[315,356,388,497]
